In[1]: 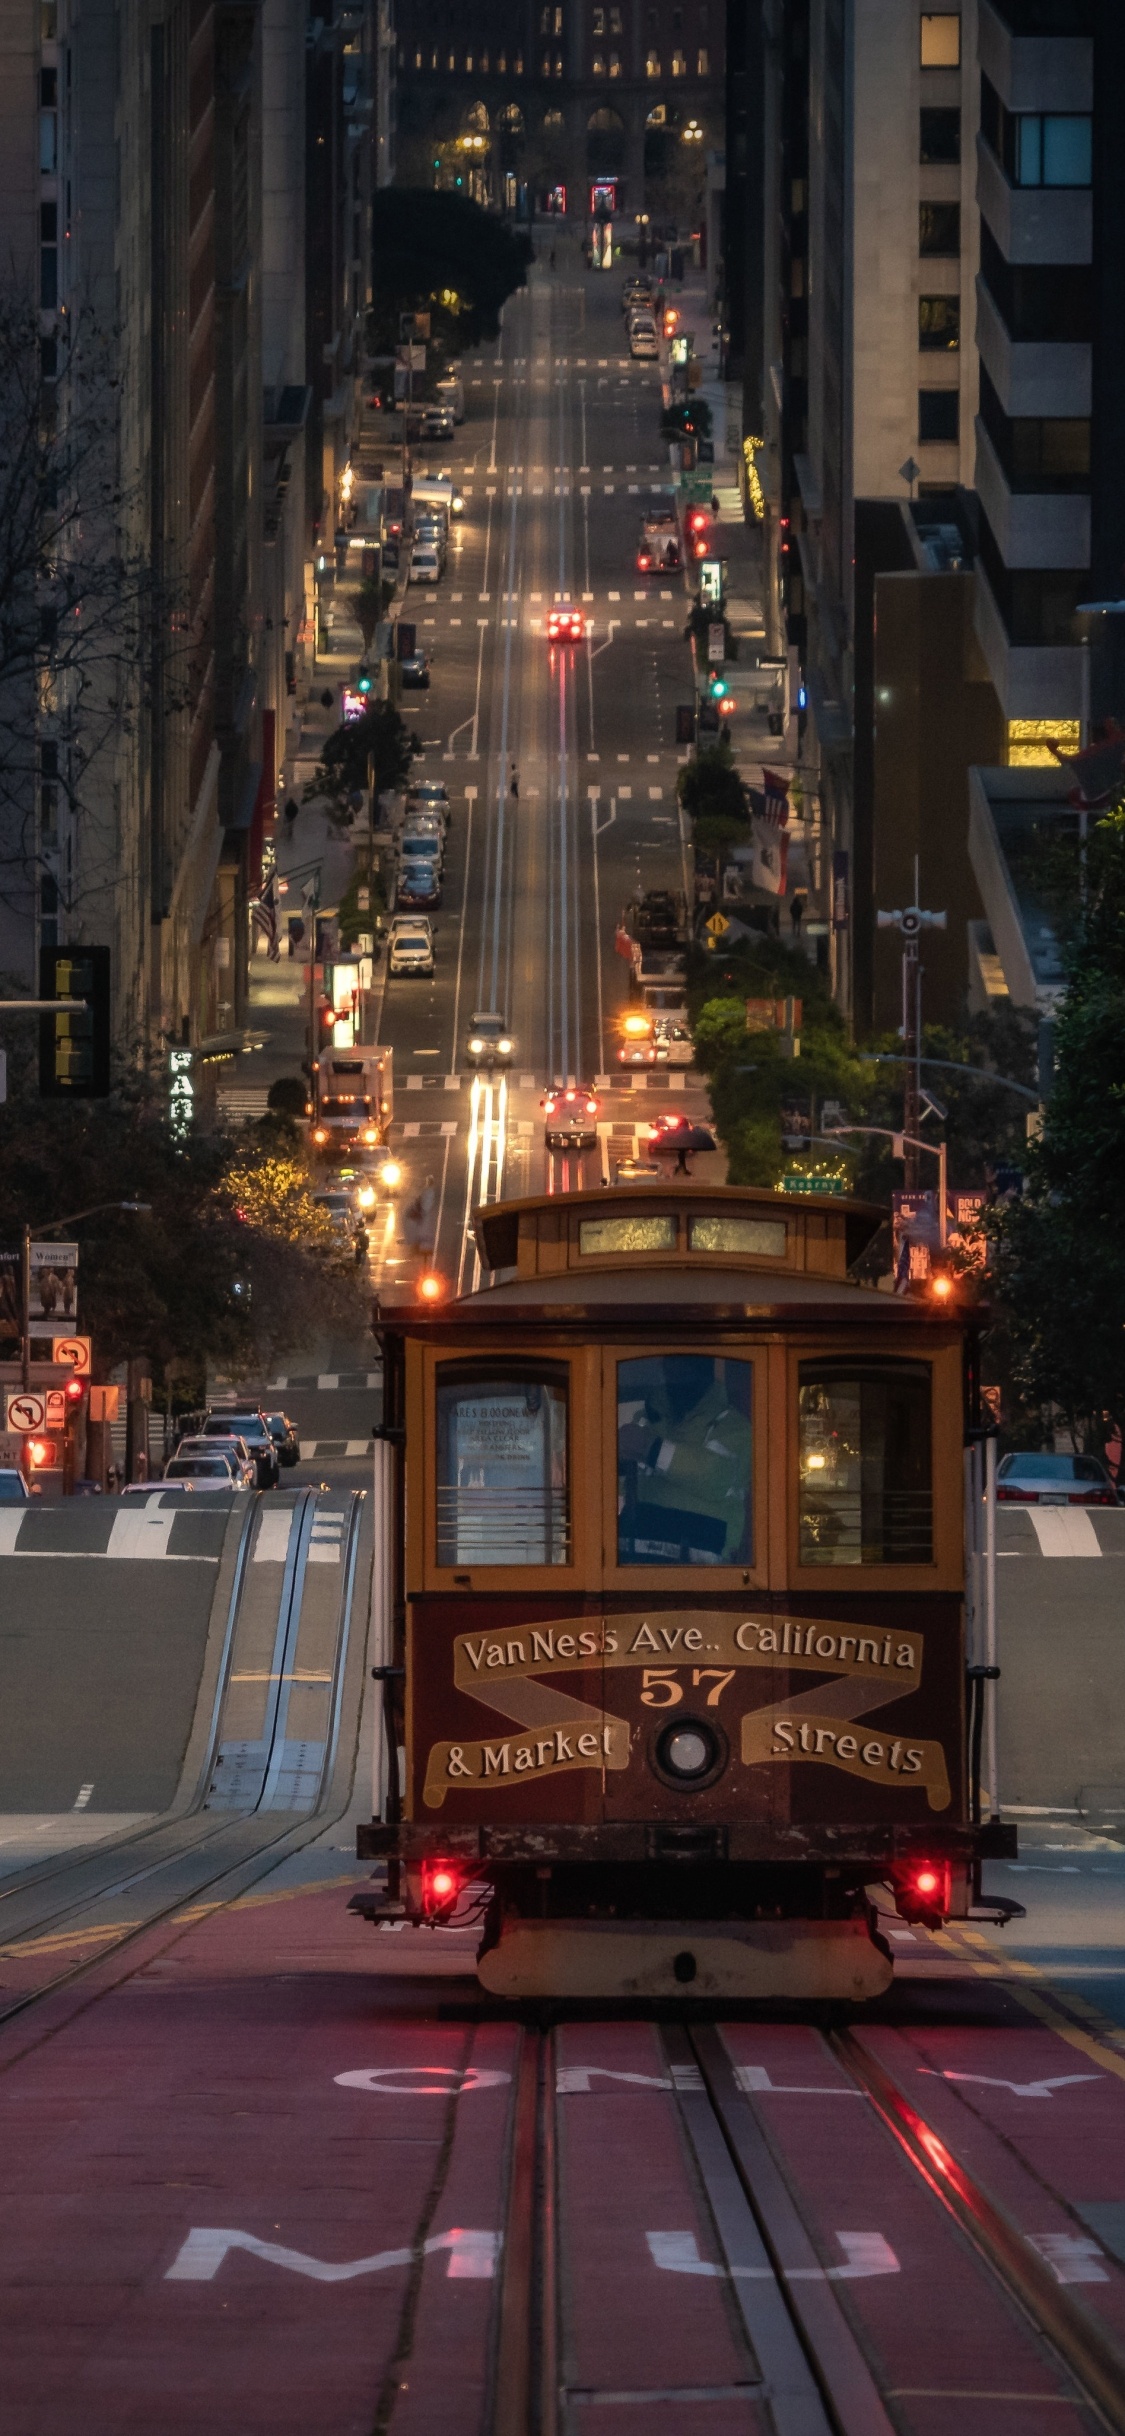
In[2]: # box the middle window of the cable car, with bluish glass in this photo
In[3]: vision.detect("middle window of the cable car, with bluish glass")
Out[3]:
[616,1354,752,1564]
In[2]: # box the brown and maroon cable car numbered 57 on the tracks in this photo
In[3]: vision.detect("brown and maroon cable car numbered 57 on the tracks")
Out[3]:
[353,1179,1015,2000]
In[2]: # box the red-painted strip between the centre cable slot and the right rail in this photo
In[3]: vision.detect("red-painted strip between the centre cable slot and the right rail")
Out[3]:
[723,2024,1096,2436]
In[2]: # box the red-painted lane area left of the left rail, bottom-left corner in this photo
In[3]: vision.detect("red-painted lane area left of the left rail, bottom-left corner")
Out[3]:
[0,1888,516,2436]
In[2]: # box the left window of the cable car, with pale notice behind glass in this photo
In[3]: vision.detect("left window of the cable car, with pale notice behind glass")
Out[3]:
[436,1362,570,1566]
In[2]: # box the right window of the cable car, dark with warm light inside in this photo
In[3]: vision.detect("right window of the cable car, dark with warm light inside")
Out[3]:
[799,1359,933,1564]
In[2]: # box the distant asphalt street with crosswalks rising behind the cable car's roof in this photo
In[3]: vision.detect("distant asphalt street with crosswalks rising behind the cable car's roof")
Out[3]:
[355,246,715,1294]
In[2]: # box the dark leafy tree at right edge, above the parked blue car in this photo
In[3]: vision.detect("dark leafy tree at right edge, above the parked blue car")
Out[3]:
[989,804,1125,1452]
